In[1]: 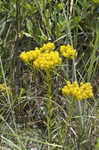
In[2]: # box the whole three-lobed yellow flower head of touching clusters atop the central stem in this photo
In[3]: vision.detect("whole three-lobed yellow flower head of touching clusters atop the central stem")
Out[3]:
[20,42,62,70]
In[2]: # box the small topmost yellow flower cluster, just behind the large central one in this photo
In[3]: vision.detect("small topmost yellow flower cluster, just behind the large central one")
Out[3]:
[40,42,55,52]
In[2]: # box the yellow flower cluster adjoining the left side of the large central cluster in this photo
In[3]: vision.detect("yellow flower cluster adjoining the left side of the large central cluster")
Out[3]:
[20,48,40,64]
